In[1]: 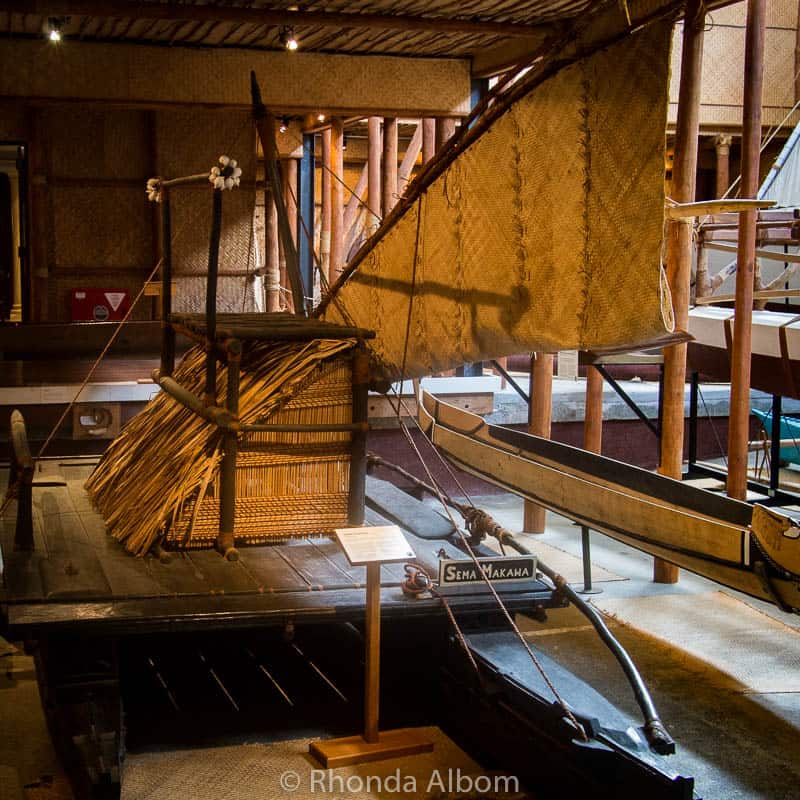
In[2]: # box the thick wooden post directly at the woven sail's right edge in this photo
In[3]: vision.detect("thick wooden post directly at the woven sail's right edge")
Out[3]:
[653,0,705,583]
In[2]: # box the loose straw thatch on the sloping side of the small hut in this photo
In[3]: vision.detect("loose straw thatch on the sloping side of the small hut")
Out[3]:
[86,339,354,555]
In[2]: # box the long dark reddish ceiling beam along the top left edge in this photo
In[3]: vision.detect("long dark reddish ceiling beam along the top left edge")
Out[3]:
[0,0,548,37]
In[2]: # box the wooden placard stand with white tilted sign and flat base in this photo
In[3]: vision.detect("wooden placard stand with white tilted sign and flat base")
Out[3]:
[308,525,433,767]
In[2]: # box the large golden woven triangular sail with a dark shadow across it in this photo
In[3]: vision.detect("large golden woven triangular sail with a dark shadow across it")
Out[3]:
[326,24,670,377]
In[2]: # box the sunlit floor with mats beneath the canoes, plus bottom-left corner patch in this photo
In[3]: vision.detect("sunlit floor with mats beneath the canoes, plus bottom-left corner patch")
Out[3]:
[0,495,800,800]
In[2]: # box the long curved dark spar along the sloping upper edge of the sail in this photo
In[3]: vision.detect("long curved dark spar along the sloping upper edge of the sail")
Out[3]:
[314,2,681,316]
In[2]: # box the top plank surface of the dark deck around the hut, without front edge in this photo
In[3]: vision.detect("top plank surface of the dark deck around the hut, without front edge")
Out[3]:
[0,459,458,606]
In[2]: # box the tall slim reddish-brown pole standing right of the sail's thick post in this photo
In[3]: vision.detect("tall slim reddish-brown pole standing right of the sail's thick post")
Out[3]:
[727,0,766,499]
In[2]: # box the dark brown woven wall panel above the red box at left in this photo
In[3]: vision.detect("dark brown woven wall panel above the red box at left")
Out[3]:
[50,186,155,272]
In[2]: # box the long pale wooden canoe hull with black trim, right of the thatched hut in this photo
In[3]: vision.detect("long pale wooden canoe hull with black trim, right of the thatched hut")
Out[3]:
[419,392,800,609]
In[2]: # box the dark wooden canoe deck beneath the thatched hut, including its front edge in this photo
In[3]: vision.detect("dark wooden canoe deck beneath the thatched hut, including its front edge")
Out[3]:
[0,459,551,630]
